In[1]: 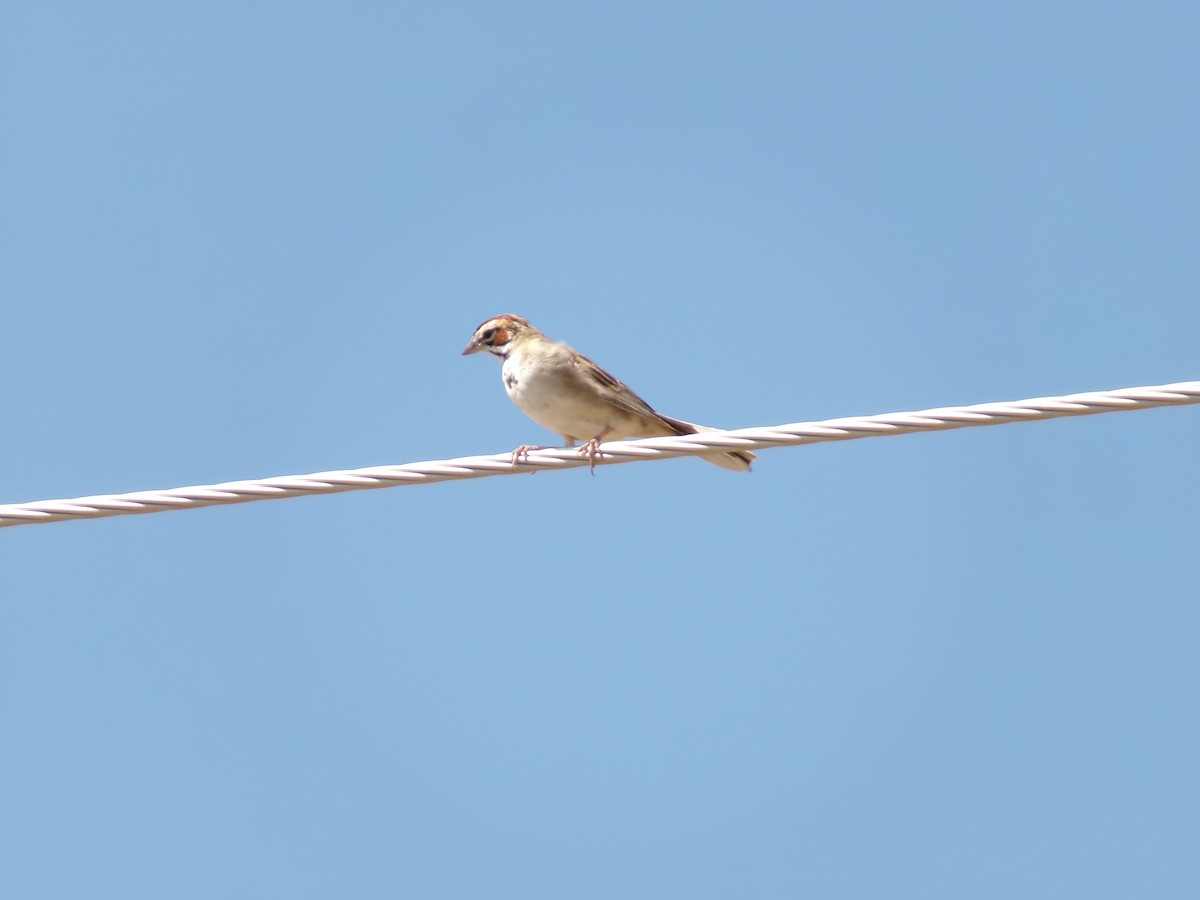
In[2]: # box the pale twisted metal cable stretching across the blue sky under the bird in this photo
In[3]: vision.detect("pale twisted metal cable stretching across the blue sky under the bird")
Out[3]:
[0,382,1200,528]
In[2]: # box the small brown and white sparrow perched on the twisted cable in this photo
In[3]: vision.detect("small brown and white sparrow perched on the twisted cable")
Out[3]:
[462,313,755,474]
